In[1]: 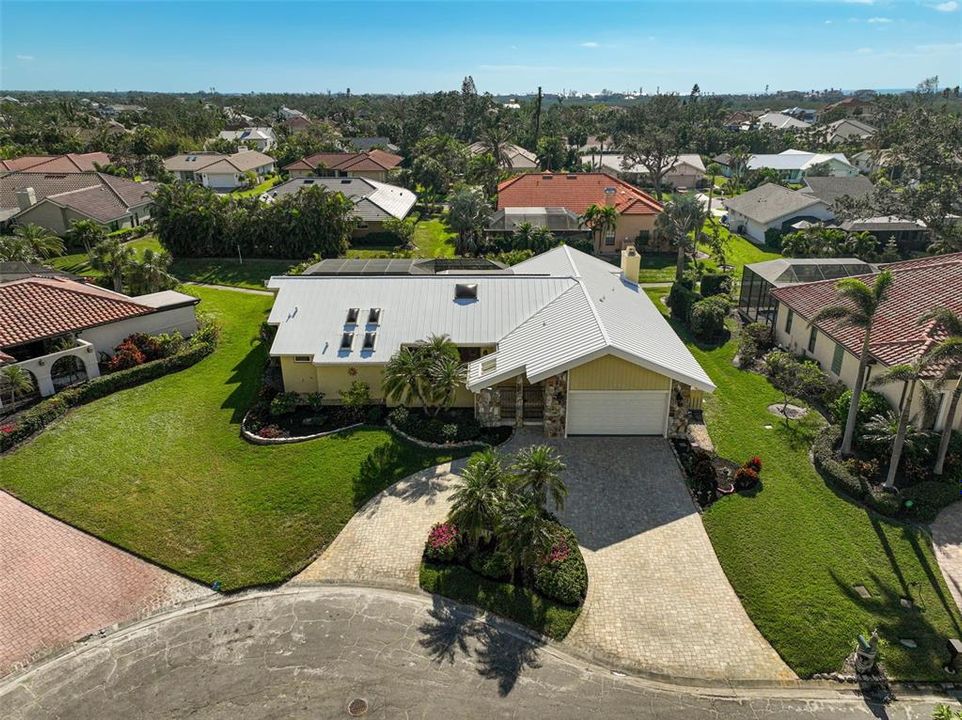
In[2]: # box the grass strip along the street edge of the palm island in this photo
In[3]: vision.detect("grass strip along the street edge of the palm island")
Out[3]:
[420,562,581,640]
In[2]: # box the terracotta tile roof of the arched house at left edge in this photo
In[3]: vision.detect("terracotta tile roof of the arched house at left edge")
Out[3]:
[0,278,154,350]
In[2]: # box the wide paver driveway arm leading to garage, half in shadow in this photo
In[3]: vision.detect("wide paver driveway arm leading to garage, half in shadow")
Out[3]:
[505,433,795,681]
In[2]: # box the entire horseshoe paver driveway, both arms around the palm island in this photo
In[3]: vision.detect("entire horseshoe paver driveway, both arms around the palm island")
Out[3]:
[293,431,795,681]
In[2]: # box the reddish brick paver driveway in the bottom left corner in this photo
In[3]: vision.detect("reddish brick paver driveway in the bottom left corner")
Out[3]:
[0,492,210,675]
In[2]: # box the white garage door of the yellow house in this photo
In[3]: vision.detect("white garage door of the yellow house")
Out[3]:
[568,390,668,435]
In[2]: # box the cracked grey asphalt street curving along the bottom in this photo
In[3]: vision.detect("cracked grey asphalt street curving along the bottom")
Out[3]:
[0,586,934,720]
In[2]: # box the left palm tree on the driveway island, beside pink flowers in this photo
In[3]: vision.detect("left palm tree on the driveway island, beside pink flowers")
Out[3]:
[448,448,505,549]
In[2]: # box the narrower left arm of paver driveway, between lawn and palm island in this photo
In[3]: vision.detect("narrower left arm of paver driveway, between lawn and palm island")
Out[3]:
[292,460,464,590]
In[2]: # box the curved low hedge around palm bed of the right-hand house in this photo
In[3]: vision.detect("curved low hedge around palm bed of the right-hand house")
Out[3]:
[812,425,959,523]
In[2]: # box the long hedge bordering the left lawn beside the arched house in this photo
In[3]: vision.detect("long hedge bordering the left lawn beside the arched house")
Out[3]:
[0,341,216,452]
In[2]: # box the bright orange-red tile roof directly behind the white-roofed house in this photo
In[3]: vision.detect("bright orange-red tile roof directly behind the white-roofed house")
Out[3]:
[498,173,662,215]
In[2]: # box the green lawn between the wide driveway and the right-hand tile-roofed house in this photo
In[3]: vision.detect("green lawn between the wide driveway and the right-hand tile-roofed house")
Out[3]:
[648,289,962,680]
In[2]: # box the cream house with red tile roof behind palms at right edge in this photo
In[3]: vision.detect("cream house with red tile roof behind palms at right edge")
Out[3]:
[772,253,962,430]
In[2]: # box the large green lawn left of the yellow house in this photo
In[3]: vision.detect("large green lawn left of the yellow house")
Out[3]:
[0,288,458,590]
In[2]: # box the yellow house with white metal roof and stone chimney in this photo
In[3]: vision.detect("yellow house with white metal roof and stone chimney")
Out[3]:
[268,246,714,437]
